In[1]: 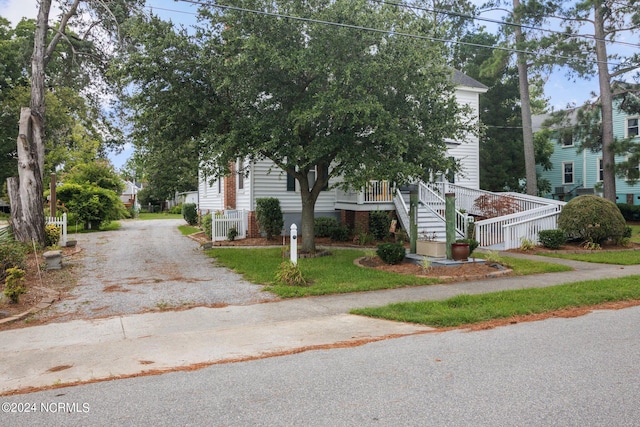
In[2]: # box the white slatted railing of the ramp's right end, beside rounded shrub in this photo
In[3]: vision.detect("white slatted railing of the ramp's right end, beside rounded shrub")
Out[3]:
[475,204,562,249]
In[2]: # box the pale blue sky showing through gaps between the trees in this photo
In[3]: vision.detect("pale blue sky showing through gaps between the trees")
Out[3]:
[0,0,640,168]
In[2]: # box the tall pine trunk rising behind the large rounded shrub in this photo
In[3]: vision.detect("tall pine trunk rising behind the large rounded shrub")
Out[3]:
[593,1,616,203]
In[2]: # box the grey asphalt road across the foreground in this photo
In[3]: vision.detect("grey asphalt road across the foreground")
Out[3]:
[5,307,640,426]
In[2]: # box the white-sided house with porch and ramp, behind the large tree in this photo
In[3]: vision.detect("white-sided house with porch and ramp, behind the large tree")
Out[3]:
[198,71,559,251]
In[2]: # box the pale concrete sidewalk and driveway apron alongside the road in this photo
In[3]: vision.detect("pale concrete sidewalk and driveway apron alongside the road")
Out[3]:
[0,254,640,394]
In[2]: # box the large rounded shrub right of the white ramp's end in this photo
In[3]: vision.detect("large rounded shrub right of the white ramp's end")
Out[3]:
[558,195,627,244]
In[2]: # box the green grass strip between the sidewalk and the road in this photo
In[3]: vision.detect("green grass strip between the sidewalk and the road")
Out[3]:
[351,276,640,327]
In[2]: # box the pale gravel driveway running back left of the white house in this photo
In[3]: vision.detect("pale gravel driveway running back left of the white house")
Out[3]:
[40,219,277,320]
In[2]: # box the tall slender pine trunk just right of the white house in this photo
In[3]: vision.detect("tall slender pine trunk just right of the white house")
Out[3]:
[513,0,538,196]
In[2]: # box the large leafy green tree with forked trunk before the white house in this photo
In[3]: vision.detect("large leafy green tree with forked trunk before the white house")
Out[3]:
[116,0,475,250]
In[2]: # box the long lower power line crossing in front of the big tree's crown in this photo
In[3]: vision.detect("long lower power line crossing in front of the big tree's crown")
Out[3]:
[177,0,622,66]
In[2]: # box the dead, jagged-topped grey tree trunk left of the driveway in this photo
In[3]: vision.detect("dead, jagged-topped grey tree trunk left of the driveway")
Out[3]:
[7,108,45,245]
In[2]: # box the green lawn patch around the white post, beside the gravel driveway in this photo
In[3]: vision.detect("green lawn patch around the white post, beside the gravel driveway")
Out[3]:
[207,248,438,298]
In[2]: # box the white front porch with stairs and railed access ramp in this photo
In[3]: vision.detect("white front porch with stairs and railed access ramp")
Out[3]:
[336,181,565,250]
